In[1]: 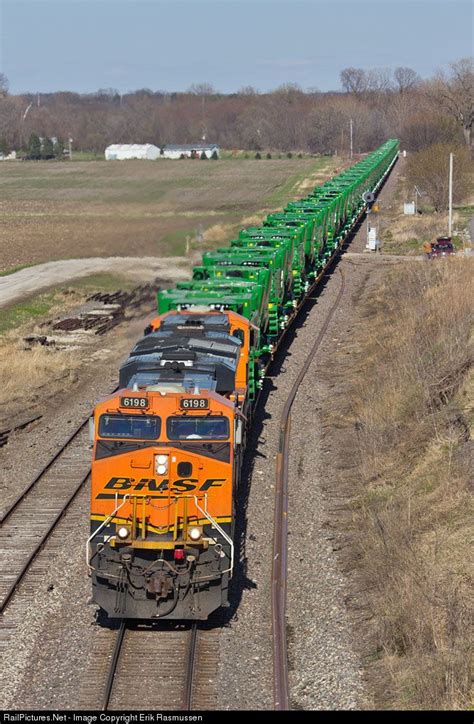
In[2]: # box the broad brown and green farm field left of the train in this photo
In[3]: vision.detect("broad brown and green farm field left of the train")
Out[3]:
[0,157,341,272]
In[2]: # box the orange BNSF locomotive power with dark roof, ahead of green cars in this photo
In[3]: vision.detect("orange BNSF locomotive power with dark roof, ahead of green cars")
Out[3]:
[87,309,255,619]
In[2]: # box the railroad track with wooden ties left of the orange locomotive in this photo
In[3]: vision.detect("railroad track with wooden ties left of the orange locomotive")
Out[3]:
[0,419,90,613]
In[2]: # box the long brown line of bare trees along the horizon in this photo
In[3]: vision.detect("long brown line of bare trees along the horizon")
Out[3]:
[0,58,474,153]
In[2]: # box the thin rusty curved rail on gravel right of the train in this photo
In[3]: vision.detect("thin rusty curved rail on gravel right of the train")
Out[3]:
[272,270,345,710]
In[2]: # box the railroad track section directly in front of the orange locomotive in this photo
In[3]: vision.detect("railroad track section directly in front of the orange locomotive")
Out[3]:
[101,621,219,711]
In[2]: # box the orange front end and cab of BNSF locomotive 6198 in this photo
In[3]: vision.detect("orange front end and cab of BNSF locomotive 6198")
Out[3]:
[87,385,241,619]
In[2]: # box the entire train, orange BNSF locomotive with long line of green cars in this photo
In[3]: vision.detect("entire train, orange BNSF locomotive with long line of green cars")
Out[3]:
[87,140,399,620]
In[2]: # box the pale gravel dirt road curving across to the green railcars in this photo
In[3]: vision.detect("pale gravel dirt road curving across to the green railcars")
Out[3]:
[0,256,190,307]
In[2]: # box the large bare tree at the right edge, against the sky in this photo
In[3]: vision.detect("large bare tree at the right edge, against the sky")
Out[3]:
[429,58,474,146]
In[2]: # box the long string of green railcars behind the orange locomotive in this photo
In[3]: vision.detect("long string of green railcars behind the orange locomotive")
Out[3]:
[158,139,399,348]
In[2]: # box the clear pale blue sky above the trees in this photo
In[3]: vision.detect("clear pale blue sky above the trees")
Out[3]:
[0,0,473,93]
